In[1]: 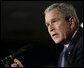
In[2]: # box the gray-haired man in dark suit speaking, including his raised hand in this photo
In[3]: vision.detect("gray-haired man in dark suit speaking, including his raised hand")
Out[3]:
[11,3,83,67]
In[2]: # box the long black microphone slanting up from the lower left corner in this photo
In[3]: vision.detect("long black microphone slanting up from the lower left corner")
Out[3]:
[1,44,33,67]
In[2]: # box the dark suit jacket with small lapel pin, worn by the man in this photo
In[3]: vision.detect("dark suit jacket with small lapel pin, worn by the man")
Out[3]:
[58,28,83,67]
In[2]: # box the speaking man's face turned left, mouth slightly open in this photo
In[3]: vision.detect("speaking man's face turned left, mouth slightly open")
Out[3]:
[45,9,71,44]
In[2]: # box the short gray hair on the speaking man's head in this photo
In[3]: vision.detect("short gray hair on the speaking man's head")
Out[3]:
[44,3,79,27]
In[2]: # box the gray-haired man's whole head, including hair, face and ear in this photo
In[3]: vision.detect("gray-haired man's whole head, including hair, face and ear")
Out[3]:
[44,3,79,44]
